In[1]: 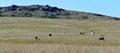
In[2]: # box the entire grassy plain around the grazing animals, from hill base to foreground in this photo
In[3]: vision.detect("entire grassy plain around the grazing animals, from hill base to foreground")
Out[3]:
[0,17,120,53]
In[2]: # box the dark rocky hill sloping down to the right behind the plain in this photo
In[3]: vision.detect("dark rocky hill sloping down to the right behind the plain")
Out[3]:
[0,5,120,20]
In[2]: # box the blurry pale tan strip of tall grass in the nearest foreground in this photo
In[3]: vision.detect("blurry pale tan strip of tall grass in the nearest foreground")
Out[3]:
[0,44,120,53]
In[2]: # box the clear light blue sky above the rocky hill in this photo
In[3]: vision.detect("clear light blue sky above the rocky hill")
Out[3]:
[0,0,120,17]
